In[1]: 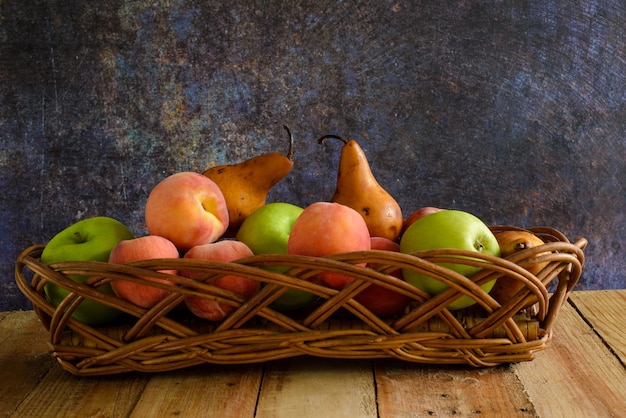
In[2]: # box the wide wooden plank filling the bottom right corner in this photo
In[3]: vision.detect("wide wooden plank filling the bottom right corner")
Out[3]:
[514,298,626,417]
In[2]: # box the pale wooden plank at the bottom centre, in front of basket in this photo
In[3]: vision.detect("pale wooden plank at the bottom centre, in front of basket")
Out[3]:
[256,357,377,418]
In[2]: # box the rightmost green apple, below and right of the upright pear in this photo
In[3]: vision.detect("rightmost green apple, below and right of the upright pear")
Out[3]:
[400,210,500,309]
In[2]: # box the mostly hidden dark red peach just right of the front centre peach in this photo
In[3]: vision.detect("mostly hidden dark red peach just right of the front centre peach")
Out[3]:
[354,237,411,318]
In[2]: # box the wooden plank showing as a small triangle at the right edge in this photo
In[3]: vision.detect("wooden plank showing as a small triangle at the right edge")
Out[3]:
[570,290,626,365]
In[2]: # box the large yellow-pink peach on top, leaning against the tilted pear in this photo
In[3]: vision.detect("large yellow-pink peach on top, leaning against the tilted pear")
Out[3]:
[146,172,229,252]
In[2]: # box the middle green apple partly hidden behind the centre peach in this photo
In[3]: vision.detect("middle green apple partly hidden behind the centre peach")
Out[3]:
[235,202,315,311]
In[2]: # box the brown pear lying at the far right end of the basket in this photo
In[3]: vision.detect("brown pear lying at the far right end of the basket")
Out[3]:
[489,230,546,307]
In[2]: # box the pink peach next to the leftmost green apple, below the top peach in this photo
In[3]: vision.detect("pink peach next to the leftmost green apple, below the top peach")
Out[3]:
[109,235,179,308]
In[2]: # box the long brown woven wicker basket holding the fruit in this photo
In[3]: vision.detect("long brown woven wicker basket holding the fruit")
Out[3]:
[15,226,587,375]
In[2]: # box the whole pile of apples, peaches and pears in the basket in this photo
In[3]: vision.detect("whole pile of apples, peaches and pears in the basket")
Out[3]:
[41,131,543,325]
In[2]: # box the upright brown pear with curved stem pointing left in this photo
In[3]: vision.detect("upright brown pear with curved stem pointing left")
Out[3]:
[318,135,403,241]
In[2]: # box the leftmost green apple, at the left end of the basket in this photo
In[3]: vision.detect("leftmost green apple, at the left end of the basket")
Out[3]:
[41,216,134,325]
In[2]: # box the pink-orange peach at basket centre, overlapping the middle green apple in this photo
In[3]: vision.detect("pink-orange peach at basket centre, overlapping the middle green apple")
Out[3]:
[287,202,371,289]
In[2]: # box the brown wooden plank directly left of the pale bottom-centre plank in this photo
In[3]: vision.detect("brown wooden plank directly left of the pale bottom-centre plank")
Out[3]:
[131,364,263,418]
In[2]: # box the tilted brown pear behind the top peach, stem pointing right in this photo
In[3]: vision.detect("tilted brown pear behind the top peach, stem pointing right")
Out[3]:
[203,126,293,233]
